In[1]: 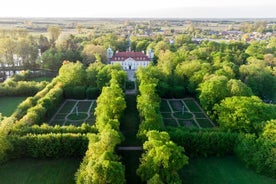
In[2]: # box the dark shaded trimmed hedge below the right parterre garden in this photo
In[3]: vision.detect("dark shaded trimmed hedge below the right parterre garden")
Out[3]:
[167,128,238,158]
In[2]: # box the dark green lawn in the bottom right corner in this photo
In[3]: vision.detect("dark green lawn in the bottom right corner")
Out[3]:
[180,156,276,184]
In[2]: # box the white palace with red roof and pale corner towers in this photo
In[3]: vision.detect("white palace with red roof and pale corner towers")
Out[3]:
[107,48,154,70]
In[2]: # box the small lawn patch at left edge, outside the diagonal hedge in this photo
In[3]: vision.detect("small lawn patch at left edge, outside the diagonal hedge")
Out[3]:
[0,97,27,116]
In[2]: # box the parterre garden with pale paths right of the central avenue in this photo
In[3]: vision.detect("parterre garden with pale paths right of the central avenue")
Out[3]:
[160,98,215,128]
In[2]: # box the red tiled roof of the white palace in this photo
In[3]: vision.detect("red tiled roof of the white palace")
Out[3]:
[111,51,149,61]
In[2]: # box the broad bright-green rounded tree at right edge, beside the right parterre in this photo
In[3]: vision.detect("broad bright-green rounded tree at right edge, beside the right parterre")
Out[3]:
[214,96,276,133]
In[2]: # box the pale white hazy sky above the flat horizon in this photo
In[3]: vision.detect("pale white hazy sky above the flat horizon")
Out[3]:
[0,0,276,18]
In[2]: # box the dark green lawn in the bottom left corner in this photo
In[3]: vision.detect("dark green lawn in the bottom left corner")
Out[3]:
[0,158,81,184]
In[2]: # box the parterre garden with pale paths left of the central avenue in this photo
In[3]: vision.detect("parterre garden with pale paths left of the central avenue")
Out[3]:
[49,100,96,126]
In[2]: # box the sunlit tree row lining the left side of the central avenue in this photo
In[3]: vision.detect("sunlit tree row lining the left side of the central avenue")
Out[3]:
[76,71,126,183]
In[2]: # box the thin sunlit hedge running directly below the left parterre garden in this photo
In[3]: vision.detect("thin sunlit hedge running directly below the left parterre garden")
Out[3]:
[10,123,98,136]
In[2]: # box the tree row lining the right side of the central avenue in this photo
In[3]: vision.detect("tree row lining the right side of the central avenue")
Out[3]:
[136,66,188,183]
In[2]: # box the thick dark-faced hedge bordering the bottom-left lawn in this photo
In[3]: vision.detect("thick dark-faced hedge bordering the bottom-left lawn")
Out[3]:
[7,133,88,159]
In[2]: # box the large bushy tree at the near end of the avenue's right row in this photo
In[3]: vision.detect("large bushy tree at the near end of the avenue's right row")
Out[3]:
[137,130,188,183]
